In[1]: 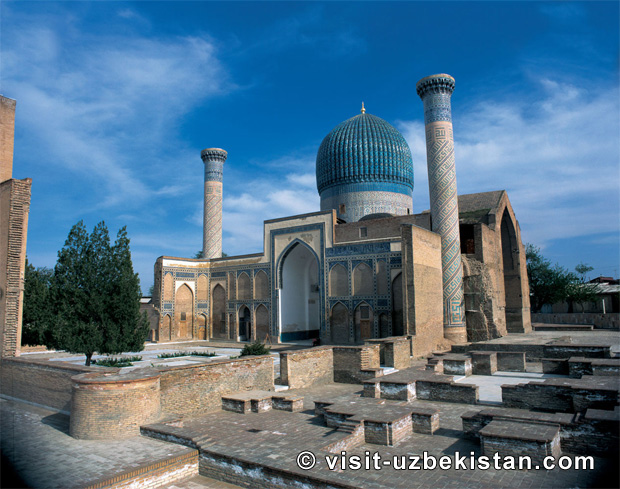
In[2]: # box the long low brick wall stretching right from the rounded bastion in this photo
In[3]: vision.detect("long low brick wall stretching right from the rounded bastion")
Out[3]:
[157,355,274,416]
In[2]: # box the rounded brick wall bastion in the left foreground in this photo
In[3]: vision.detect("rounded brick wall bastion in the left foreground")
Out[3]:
[69,367,160,440]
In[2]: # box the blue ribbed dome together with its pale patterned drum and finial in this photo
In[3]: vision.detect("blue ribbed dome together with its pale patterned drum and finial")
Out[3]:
[316,104,413,222]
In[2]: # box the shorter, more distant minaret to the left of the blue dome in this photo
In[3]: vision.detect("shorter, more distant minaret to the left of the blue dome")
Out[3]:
[200,148,228,259]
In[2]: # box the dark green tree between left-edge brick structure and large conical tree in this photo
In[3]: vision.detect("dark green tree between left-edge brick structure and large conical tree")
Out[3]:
[22,259,53,345]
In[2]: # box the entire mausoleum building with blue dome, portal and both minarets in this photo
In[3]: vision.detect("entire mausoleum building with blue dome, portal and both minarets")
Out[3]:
[153,75,531,356]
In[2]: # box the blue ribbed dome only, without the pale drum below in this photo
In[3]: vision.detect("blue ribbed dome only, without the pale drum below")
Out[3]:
[316,113,413,194]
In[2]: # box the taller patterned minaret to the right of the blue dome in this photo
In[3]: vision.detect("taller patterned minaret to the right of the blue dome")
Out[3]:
[416,74,467,343]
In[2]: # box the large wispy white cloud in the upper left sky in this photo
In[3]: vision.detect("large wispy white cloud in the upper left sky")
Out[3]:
[2,14,234,210]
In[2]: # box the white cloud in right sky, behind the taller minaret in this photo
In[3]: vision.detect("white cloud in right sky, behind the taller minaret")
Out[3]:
[400,78,620,246]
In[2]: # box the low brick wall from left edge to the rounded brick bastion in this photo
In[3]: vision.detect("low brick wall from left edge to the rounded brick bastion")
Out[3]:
[0,357,103,413]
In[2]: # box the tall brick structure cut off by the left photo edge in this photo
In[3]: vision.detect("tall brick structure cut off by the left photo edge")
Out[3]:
[0,95,32,358]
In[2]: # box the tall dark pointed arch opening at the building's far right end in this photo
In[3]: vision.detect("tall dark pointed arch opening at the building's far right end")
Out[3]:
[501,209,523,333]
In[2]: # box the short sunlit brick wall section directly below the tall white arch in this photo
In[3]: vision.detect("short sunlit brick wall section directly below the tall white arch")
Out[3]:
[280,346,334,389]
